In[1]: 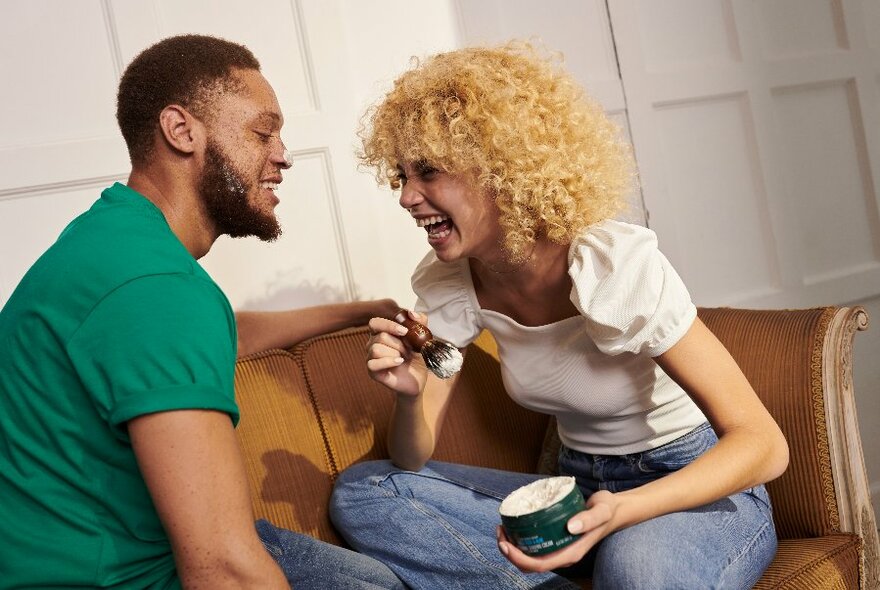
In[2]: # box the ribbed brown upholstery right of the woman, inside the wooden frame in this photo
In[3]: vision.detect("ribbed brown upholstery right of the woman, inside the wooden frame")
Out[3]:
[700,308,839,539]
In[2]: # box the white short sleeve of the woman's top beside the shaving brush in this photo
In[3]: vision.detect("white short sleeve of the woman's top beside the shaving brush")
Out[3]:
[412,250,483,348]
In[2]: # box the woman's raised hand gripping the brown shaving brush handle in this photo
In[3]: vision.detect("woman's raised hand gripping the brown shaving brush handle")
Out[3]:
[367,311,428,396]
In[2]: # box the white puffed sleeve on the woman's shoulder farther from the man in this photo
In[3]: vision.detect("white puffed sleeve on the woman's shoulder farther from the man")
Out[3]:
[568,221,697,357]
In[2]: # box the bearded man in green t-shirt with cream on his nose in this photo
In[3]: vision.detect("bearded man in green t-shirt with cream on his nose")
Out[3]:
[0,35,402,589]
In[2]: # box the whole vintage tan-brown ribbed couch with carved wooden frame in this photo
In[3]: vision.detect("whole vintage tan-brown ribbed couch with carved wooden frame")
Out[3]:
[235,308,880,590]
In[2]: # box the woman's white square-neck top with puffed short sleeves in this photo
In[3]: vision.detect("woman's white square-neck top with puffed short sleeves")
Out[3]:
[412,220,705,455]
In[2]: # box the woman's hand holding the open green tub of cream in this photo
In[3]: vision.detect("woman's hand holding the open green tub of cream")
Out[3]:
[496,490,619,572]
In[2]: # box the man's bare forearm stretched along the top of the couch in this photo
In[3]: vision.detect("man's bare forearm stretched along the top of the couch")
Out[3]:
[235,299,399,358]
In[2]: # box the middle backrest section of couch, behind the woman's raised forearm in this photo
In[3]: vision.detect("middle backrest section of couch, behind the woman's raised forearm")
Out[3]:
[296,328,547,472]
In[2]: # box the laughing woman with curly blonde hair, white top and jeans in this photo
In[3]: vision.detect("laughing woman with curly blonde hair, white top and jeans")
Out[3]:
[331,45,788,589]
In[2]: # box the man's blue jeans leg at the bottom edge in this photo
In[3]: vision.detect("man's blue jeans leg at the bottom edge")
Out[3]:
[256,520,406,590]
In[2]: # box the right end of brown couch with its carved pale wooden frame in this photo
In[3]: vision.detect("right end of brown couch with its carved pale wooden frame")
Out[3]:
[700,307,880,588]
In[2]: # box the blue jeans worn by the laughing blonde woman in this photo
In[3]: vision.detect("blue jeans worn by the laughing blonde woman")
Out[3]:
[330,424,776,590]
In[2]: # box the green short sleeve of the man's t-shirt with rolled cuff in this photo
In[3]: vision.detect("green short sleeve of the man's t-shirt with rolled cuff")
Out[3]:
[67,274,239,437]
